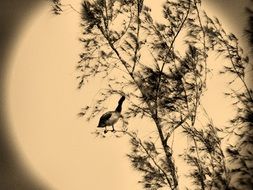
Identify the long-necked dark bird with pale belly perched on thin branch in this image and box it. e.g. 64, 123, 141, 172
97, 96, 125, 133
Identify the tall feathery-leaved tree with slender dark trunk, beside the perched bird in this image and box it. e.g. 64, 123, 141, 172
50, 0, 252, 190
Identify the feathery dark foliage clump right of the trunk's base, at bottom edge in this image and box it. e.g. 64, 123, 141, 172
183, 121, 230, 190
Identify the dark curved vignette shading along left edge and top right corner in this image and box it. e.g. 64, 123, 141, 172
0, 0, 253, 190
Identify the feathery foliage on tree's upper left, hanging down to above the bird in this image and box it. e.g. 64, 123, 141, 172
77, 0, 140, 120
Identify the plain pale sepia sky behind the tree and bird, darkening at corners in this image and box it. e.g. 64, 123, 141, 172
0, 0, 252, 190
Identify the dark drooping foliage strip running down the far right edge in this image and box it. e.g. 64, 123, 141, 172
203, 13, 253, 189
